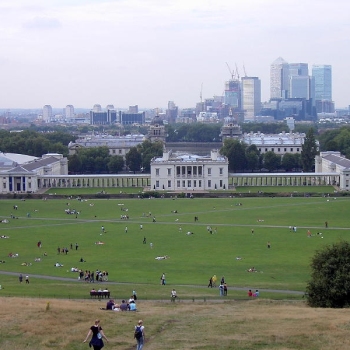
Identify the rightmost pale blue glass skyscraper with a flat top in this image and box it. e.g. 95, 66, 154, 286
312, 64, 332, 101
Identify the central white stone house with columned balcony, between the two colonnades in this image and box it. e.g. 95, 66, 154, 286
151, 150, 228, 192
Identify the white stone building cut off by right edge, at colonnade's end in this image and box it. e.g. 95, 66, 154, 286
315, 151, 350, 191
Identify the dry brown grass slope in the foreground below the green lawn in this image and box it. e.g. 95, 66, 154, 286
0, 298, 350, 350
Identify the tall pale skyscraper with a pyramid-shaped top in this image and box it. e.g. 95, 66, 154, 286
270, 57, 289, 99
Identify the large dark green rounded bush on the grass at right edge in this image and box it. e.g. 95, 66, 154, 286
306, 241, 350, 308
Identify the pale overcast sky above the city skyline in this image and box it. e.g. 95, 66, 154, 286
0, 0, 350, 109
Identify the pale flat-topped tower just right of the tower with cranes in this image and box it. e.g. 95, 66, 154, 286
242, 77, 261, 121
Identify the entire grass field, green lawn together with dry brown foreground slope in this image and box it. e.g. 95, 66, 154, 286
0, 196, 350, 350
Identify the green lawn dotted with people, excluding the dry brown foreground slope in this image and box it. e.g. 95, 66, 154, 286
0, 197, 350, 299
